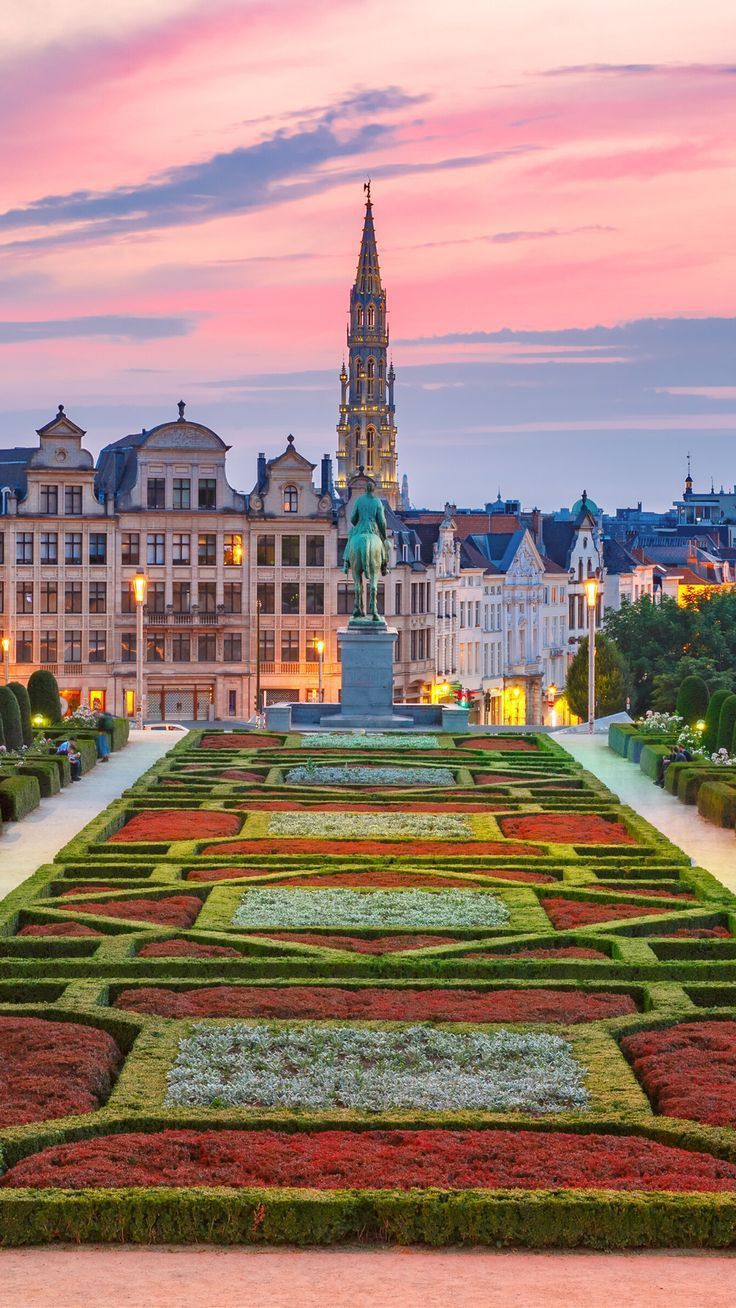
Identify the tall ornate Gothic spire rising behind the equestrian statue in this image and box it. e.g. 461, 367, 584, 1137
337, 182, 399, 509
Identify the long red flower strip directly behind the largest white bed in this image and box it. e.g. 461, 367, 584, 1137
114, 985, 638, 1023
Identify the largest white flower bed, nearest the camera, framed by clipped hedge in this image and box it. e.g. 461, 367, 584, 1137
166, 1023, 588, 1113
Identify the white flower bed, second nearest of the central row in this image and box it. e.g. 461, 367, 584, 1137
233, 887, 509, 927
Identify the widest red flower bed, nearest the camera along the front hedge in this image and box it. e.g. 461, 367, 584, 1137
0, 1130, 736, 1193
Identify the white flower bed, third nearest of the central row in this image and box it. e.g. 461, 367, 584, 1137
268, 812, 473, 840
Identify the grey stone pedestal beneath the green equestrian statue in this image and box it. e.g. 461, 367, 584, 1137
322, 617, 414, 730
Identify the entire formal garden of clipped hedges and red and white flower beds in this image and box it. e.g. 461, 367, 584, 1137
0, 730, 736, 1248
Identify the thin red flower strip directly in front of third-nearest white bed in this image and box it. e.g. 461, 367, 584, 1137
201, 837, 543, 858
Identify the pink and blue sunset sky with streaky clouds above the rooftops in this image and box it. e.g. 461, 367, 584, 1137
0, 0, 736, 510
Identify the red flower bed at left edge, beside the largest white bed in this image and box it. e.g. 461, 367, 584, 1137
0, 1018, 123, 1126
